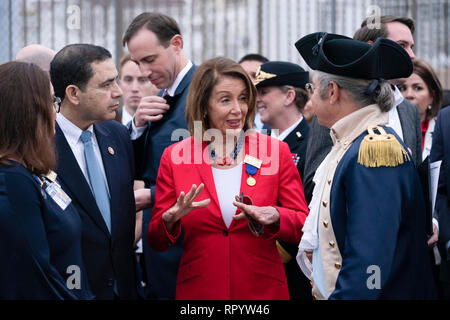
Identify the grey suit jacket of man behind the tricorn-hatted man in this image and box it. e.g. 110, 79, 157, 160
303, 99, 422, 203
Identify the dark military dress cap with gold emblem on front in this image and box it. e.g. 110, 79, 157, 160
255, 61, 309, 89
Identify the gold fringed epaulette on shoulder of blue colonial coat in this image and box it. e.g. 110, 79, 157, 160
358, 126, 411, 168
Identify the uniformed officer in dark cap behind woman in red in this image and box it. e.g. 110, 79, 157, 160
254, 61, 312, 300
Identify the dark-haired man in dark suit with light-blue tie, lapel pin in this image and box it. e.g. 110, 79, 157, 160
50, 44, 139, 299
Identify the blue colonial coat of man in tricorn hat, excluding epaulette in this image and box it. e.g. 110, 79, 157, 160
329, 127, 436, 300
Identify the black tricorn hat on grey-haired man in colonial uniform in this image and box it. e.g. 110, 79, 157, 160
295, 32, 413, 80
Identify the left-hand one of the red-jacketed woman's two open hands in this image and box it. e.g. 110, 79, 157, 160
162, 183, 211, 233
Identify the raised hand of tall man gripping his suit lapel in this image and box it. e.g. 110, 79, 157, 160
134, 96, 170, 128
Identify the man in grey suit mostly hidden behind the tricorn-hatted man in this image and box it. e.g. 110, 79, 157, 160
303, 16, 422, 203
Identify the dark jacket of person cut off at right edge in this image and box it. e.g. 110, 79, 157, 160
430, 108, 450, 285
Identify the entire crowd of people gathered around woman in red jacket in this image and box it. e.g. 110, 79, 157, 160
0, 12, 450, 300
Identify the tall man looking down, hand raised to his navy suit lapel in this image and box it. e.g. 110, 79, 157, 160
123, 13, 195, 299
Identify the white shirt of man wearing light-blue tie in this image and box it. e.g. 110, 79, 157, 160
56, 113, 109, 192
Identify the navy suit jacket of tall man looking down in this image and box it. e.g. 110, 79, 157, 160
133, 65, 196, 299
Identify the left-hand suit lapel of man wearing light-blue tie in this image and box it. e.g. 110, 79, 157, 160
55, 124, 110, 237
